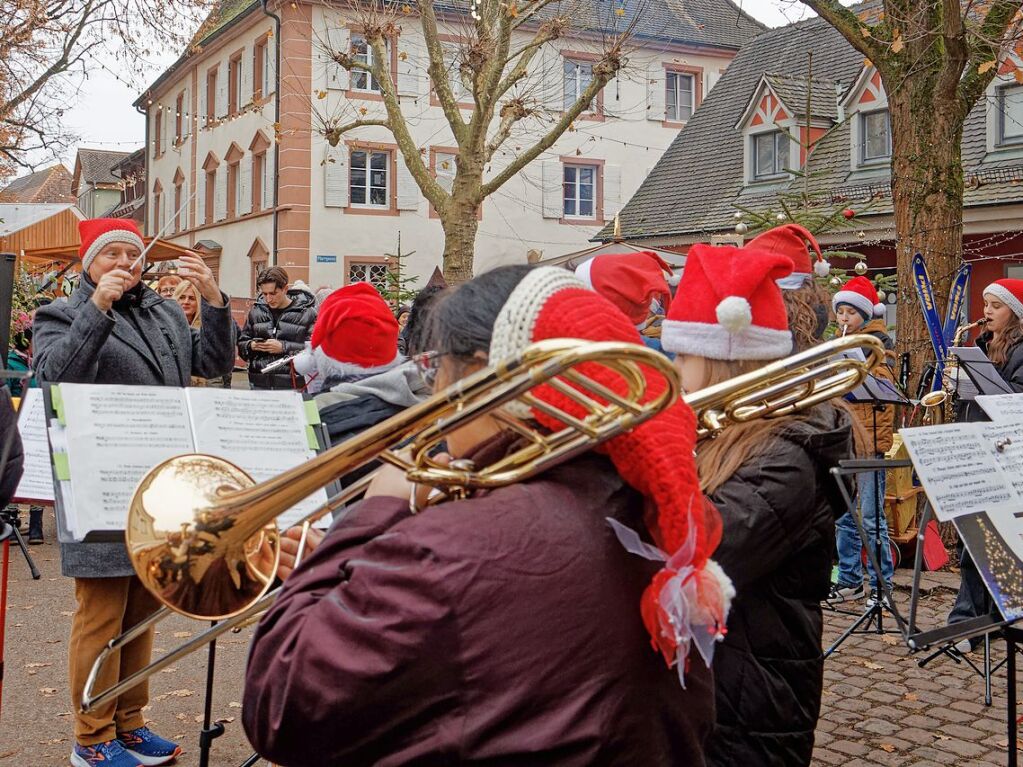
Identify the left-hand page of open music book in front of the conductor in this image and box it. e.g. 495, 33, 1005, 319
60, 384, 193, 537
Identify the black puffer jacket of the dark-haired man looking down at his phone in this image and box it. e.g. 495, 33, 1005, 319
238, 287, 316, 389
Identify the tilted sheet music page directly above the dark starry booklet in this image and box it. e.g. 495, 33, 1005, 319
899, 423, 1023, 522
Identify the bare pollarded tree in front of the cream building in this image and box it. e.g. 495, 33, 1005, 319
318, 0, 638, 281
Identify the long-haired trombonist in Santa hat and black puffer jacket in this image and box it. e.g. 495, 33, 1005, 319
661, 244, 853, 767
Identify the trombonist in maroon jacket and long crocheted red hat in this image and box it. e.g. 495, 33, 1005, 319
242, 266, 729, 766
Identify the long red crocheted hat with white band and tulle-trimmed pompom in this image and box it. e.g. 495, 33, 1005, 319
490, 267, 735, 684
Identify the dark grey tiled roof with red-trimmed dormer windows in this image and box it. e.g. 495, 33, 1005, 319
594, 6, 1023, 240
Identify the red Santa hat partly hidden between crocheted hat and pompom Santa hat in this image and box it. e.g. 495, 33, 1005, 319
576, 251, 671, 325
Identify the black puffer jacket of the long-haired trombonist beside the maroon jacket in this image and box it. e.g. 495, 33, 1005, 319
707, 405, 853, 767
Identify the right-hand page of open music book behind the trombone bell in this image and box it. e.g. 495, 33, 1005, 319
186, 388, 330, 530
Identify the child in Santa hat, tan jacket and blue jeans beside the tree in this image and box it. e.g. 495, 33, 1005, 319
828, 277, 895, 602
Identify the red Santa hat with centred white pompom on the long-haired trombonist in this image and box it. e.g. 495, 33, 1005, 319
661, 244, 792, 360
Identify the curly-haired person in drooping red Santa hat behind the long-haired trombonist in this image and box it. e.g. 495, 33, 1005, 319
747, 224, 831, 354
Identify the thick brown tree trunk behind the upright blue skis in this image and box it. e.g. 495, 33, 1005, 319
802, 0, 1021, 386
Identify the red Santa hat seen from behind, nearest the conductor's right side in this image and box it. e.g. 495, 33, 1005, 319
312, 282, 398, 369
